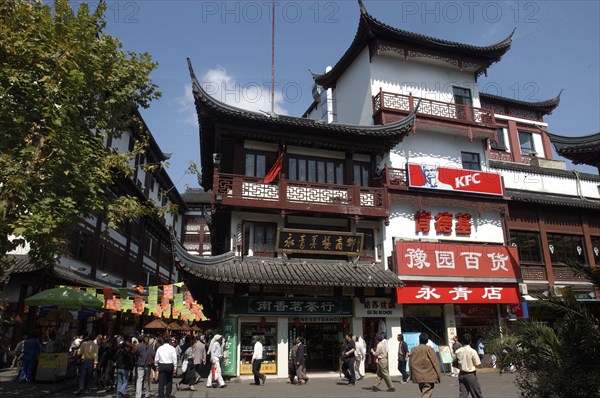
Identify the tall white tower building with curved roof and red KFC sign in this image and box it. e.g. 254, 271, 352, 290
305, 1, 520, 364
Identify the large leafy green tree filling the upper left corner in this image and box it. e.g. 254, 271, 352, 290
0, 0, 160, 272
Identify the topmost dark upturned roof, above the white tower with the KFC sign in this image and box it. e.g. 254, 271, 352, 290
311, 0, 515, 87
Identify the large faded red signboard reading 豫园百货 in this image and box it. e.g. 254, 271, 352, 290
396, 241, 520, 279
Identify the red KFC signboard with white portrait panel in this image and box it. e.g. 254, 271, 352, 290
407, 163, 504, 195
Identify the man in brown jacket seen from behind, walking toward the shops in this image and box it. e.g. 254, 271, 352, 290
409, 333, 441, 398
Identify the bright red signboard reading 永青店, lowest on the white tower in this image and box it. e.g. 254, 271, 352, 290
396, 282, 520, 304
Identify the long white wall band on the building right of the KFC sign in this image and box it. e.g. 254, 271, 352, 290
493, 169, 600, 199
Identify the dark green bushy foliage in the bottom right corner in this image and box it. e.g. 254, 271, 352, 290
488, 263, 600, 398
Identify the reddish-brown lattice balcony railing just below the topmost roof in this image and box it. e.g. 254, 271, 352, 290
373, 91, 496, 128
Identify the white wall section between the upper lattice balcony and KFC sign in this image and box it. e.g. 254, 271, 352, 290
386, 129, 488, 170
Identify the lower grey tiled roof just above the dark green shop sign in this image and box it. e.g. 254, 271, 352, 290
173, 235, 404, 288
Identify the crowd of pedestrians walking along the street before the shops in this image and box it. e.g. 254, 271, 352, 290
5, 332, 492, 398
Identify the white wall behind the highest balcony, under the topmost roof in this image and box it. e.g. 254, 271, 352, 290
371, 55, 481, 108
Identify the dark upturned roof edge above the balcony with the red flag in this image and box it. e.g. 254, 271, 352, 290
187, 58, 419, 137
